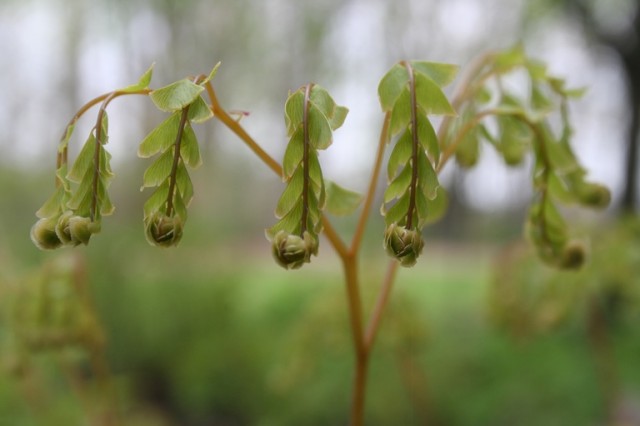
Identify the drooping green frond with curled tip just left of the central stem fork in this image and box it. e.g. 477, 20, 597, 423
266, 84, 352, 269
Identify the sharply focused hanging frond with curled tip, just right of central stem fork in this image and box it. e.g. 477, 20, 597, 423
378, 62, 457, 266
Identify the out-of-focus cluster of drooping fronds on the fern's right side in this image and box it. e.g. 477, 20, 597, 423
441, 46, 610, 268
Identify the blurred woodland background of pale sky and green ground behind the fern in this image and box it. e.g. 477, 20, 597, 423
0, 0, 640, 425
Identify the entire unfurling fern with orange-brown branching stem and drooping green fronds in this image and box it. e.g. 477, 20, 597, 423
31, 47, 610, 425
